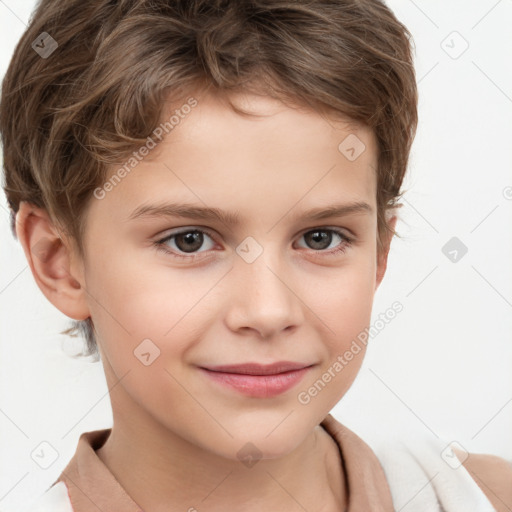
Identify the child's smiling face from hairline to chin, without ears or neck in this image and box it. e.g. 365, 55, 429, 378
68, 90, 385, 459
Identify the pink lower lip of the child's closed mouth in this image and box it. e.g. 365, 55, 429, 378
201, 367, 310, 398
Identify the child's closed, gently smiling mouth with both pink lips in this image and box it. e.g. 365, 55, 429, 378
199, 361, 315, 398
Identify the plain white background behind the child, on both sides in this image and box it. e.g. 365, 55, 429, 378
0, 0, 512, 511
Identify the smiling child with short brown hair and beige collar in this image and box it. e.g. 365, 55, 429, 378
0, 0, 512, 512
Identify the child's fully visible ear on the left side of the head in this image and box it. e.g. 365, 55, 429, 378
16, 201, 90, 320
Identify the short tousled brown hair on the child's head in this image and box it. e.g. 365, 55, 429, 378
0, 0, 417, 355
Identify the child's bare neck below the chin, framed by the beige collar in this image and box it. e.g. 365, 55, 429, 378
96, 410, 347, 512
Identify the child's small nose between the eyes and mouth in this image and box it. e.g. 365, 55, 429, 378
226, 249, 303, 339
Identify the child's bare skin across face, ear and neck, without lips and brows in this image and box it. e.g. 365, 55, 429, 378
17, 89, 396, 512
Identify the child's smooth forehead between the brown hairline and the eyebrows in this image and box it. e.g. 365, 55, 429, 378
88, 89, 377, 230
